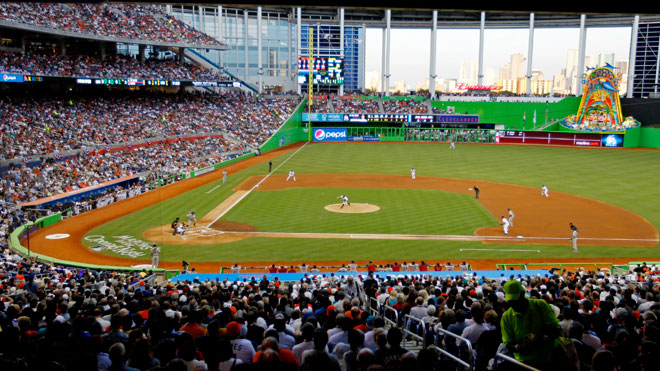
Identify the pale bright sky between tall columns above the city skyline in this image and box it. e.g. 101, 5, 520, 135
365, 27, 631, 89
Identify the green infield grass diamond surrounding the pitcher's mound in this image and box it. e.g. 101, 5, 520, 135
223, 188, 497, 234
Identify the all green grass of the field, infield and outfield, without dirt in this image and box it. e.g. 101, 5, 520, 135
88, 143, 660, 262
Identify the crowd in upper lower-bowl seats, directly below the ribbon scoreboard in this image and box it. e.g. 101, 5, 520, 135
0, 92, 297, 159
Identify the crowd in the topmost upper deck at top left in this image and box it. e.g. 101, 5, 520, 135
0, 2, 222, 46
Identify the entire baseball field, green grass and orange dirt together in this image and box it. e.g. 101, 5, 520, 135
31, 143, 660, 272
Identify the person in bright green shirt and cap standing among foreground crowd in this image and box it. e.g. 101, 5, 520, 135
501, 280, 561, 369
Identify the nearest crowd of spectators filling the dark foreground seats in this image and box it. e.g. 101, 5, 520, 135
0, 250, 660, 371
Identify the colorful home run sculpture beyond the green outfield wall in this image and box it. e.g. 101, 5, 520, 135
562, 65, 639, 131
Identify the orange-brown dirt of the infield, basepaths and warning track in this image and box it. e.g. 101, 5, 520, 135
23, 145, 658, 272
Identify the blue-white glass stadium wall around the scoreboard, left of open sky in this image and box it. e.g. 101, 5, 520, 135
165, 5, 366, 92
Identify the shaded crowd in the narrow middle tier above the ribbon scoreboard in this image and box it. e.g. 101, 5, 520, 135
0, 52, 226, 81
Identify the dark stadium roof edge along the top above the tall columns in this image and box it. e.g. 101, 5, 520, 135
172, 0, 660, 28
